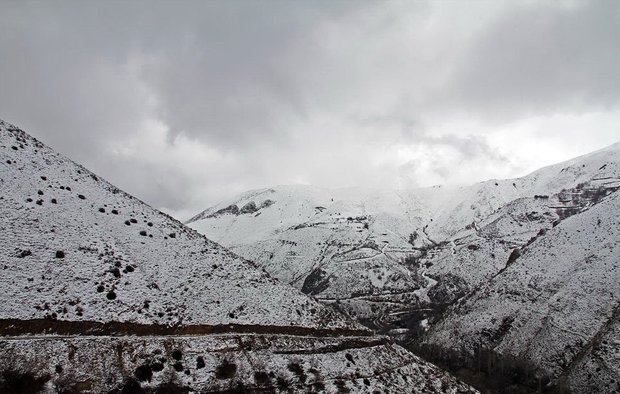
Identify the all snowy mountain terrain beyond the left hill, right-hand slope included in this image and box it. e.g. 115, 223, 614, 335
189, 143, 620, 392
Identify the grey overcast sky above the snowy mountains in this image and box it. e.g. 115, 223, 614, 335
0, 0, 620, 219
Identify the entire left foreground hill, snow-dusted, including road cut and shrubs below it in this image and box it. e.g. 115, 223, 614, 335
0, 121, 473, 393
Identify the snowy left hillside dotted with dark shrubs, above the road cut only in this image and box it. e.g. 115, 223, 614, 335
0, 122, 357, 328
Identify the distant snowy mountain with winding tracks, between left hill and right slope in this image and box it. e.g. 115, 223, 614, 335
188, 144, 620, 336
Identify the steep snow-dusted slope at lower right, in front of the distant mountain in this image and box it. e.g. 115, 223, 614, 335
425, 192, 620, 392
